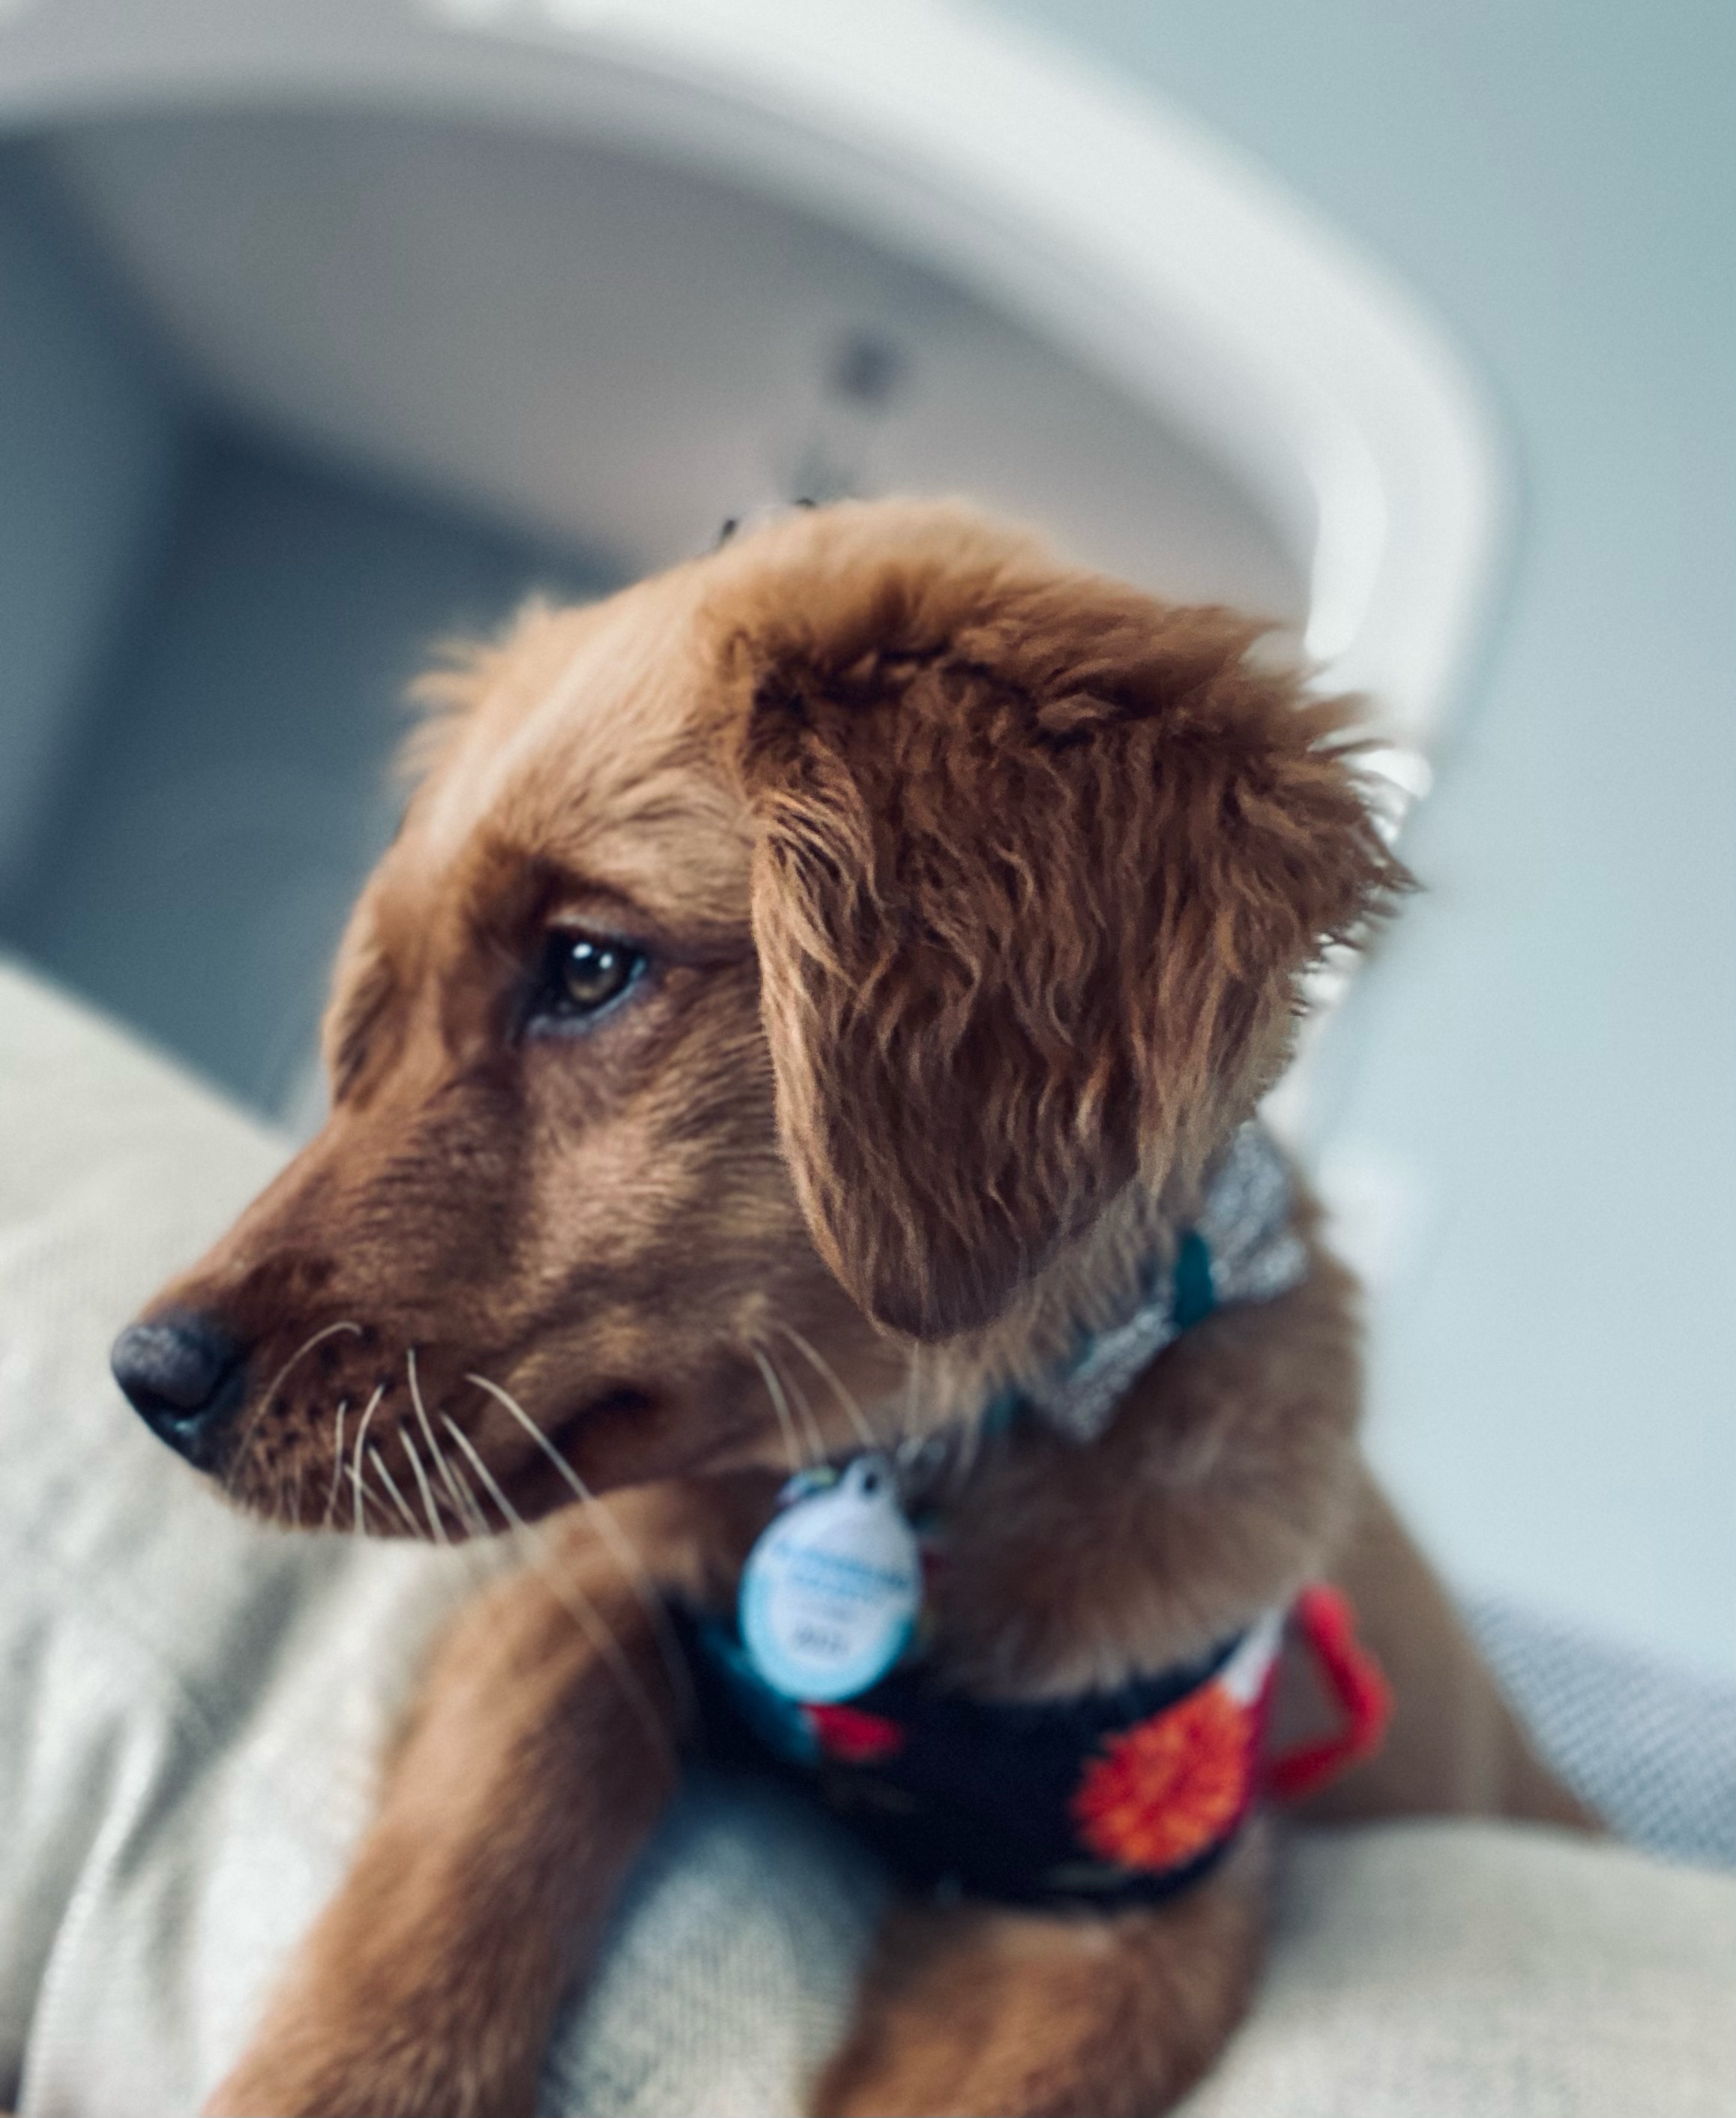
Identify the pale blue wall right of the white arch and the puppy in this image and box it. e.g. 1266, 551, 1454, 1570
1001, 0, 1736, 1669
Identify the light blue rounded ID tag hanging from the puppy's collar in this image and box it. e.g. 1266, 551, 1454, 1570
737, 1455, 923, 1705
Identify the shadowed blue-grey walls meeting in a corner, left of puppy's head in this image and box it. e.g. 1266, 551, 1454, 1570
0, 142, 612, 1119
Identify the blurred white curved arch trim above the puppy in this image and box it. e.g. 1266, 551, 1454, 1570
0, 0, 1507, 762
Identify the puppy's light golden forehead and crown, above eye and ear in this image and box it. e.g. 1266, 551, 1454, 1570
390, 502, 1040, 932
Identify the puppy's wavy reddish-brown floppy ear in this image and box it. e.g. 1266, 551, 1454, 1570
729, 517, 1405, 1338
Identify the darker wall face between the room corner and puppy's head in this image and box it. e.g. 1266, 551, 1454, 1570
6, 434, 599, 1116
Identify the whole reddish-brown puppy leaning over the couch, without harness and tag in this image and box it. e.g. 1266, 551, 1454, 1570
118, 504, 1573, 2118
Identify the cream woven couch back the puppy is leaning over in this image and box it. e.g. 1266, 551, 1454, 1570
0, 966, 1736, 2118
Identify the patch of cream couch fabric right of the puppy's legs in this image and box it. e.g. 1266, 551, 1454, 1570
1186, 1823, 1736, 2118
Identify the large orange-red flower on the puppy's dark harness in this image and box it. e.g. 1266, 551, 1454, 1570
1071, 1684, 1253, 1870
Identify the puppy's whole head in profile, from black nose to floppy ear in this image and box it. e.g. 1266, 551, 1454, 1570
116, 502, 1404, 1531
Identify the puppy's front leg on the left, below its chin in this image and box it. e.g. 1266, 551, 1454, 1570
208, 1529, 675, 2118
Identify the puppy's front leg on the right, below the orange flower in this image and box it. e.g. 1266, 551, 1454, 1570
813, 1823, 1268, 2118
